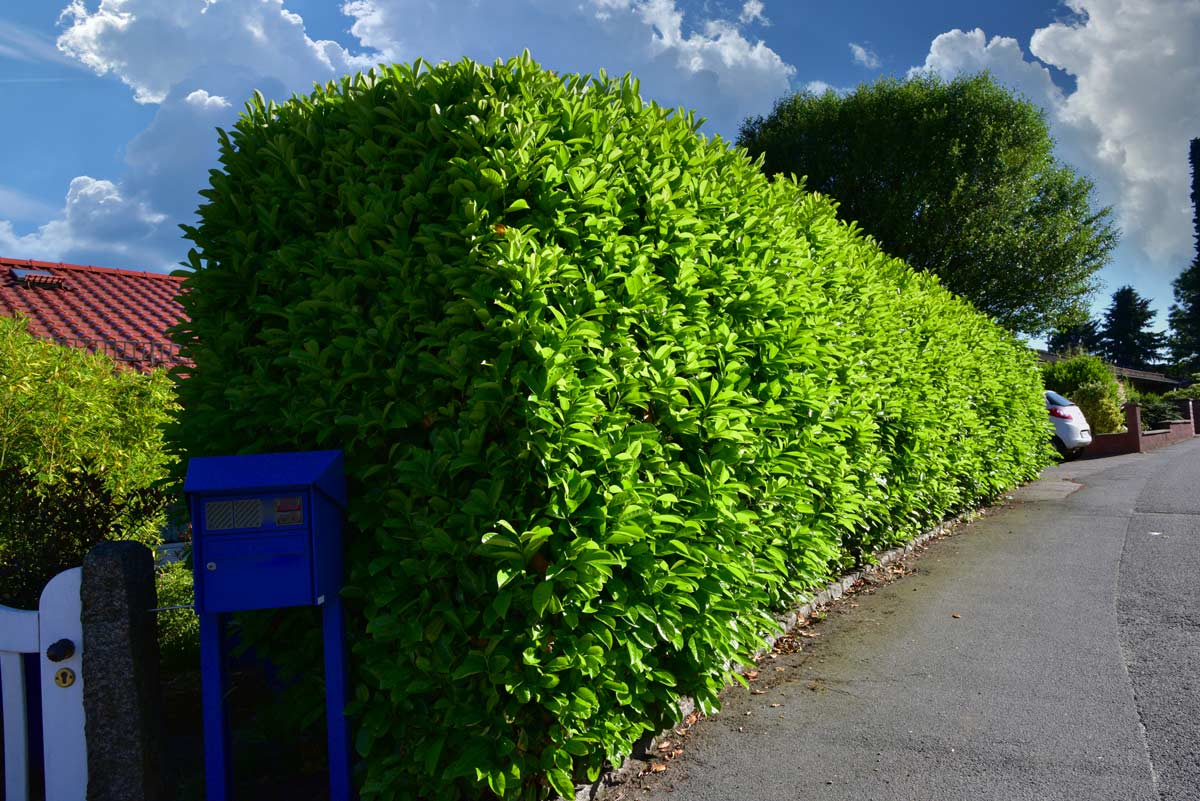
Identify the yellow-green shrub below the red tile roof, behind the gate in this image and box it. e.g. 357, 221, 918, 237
0, 317, 174, 608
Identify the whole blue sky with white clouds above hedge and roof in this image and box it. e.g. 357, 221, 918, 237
0, 0, 1200, 335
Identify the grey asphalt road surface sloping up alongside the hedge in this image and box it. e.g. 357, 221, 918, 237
618, 438, 1200, 801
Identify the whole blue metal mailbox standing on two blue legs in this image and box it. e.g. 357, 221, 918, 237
184, 451, 350, 801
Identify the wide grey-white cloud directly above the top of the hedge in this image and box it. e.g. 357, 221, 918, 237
342, 0, 796, 137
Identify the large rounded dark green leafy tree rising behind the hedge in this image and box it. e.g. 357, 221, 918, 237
738, 73, 1117, 335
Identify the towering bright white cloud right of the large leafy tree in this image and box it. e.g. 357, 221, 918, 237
920, 0, 1200, 316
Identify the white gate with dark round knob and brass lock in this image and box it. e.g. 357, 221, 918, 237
0, 567, 88, 801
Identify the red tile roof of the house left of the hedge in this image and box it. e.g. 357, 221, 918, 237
0, 257, 184, 369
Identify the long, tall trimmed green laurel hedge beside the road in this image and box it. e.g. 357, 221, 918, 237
174, 56, 1049, 800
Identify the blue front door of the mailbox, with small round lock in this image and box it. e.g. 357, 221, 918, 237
194, 529, 316, 612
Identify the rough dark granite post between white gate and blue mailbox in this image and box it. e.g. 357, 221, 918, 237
79, 541, 163, 801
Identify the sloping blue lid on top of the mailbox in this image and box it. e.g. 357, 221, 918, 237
184, 451, 346, 508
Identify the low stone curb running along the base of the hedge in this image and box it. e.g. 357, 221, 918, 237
554, 506, 984, 801
